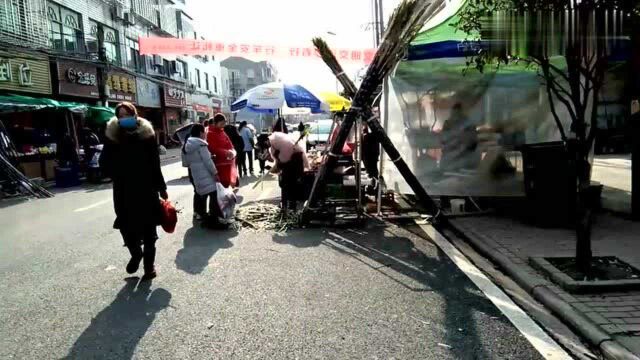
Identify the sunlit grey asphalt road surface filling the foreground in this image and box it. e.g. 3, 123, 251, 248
0, 164, 556, 359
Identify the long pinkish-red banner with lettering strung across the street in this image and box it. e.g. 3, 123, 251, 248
139, 37, 376, 65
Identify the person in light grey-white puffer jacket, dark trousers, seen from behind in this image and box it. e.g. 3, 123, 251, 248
182, 124, 221, 224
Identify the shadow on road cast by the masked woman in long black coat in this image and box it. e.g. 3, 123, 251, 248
66, 278, 171, 359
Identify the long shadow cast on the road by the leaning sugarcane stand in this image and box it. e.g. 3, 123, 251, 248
273, 224, 537, 359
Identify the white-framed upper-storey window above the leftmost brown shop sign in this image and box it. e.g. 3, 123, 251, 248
47, 2, 84, 52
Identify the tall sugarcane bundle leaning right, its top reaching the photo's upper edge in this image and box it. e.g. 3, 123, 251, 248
307, 0, 444, 205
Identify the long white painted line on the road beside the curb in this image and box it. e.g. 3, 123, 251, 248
418, 224, 571, 360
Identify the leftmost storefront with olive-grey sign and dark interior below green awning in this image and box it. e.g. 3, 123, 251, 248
0, 51, 61, 179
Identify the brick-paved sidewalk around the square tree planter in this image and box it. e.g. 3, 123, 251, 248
451, 213, 640, 355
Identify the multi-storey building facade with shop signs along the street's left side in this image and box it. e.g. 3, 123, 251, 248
0, 0, 224, 143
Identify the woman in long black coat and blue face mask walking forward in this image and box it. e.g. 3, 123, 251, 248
100, 102, 169, 280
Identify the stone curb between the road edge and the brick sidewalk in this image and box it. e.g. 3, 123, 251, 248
445, 221, 640, 360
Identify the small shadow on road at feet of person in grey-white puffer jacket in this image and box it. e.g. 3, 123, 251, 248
176, 225, 237, 275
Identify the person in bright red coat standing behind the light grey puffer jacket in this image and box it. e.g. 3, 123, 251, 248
207, 114, 238, 187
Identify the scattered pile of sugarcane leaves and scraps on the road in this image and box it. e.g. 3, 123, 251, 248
236, 202, 300, 234
